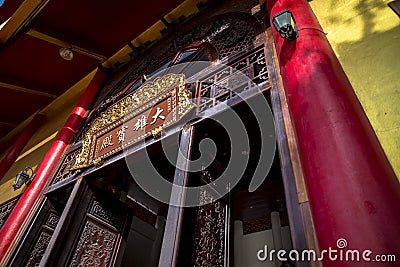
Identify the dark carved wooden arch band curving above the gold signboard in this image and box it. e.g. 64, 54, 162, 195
77, 13, 260, 152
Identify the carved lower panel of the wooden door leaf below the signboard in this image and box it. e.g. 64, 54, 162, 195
70, 220, 118, 266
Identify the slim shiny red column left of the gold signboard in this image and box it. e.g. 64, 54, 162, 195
0, 70, 105, 262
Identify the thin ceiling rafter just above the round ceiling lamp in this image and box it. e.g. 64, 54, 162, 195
26, 29, 107, 63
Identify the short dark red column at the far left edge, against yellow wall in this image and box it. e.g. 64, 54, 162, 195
0, 113, 46, 180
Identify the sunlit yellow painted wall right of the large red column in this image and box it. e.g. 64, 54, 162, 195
310, 0, 400, 178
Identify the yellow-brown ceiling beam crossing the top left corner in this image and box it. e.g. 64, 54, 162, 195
0, 0, 50, 44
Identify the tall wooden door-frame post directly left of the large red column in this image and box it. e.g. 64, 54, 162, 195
265, 28, 321, 267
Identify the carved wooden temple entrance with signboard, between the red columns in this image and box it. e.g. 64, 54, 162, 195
1, 1, 318, 267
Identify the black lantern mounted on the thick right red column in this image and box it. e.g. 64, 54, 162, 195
272, 9, 299, 40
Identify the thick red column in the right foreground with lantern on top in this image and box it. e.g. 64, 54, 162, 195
267, 0, 400, 266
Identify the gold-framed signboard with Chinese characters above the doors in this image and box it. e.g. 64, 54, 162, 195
73, 74, 194, 169
